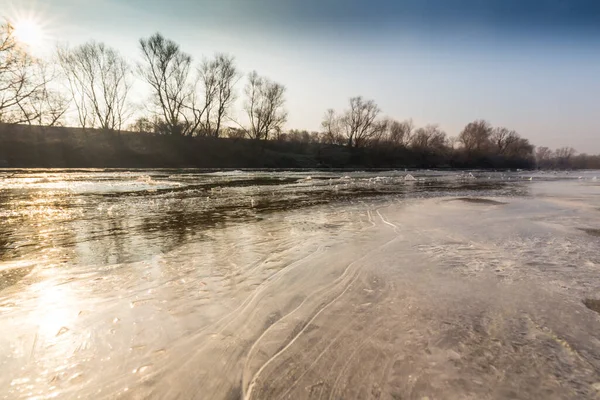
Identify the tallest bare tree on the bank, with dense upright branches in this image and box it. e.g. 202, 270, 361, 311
138, 33, 210, 136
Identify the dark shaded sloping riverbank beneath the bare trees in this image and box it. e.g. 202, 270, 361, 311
0, 124, 533, 169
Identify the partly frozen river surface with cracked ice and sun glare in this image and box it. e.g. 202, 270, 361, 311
0, 170, 600, 399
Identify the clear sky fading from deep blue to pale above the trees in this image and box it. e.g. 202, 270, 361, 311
0, 0, 600, 153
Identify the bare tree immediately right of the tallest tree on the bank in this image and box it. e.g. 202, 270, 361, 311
200, 54, 238, 137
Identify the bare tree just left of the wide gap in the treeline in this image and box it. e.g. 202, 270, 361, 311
245, 71, 287, 140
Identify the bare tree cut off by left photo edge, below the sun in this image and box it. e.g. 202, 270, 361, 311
0, 23, 66, 125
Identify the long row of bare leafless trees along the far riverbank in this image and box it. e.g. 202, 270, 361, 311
0, 23, 600, 168
